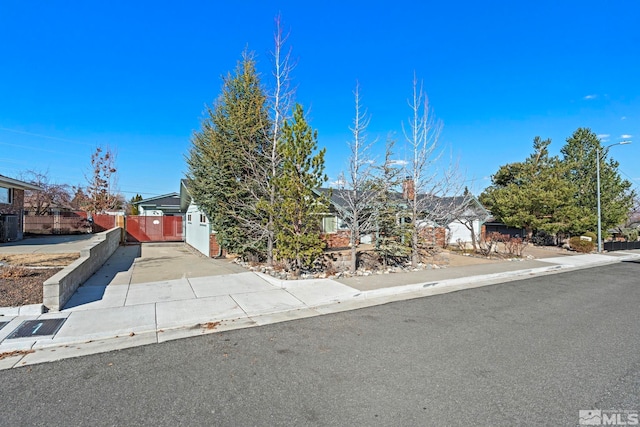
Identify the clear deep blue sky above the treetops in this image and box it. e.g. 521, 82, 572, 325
0, 0, 640, 199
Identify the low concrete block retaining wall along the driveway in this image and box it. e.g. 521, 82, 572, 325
43, 227, 122, 311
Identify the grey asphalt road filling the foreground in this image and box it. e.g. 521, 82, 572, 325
0, 262, 640, 426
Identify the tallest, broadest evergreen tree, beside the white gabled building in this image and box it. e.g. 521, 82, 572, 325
187, 53, 270, 255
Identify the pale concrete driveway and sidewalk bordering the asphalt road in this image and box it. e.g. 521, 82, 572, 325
0, 246, 640, 369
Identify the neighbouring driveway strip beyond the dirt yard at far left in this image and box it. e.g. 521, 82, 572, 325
0, 234, 95, 254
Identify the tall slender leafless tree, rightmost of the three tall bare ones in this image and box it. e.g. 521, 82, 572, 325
403, 74, 463, 267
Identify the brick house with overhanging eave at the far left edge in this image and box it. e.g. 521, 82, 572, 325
0, 175, 42, 242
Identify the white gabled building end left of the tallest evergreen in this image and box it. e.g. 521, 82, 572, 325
180, 179, 224, 258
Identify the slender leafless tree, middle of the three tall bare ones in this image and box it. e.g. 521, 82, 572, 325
337, 83, 376, 272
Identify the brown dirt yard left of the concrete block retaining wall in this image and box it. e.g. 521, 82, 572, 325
0, 253, 80, 307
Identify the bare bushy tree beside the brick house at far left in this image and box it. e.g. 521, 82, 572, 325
21, 170, 71, 215
